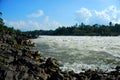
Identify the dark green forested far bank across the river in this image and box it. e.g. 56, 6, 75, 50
25, 22, 120, 36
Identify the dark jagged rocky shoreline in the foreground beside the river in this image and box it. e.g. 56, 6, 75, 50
0, 31, 120, 80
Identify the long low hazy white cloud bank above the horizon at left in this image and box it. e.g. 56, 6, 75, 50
4, 16, 61, 31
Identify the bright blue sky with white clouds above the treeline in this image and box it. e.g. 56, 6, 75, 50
0, 0, 120, 31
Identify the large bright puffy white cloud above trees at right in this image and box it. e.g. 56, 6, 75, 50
75, 5, 120, 24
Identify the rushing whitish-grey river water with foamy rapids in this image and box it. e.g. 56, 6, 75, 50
32, 36, 120, 73
